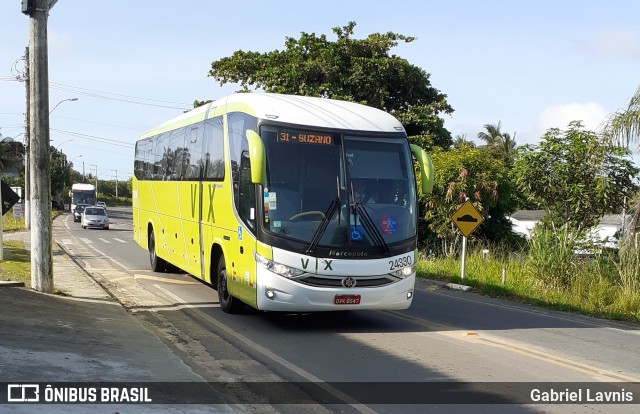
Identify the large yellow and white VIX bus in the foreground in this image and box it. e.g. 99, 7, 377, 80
133, 93, 433, 313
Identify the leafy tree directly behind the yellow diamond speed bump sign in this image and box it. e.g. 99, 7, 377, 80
421, 146, 515, 255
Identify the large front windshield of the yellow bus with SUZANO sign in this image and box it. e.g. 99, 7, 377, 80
261, 126, 416, 249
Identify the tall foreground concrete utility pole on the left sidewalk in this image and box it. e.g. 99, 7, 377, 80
23, 0, 54, 293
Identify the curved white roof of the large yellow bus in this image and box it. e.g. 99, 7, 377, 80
140, 93, 404, 138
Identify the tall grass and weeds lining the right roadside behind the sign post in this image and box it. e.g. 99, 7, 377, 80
418, 238, 640, 322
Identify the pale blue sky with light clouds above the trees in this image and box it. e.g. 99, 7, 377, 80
0, 0, 640, 180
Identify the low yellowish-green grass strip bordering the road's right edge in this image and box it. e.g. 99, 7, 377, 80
418, 246, 640, 322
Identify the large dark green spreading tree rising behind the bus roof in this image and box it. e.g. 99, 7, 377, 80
208, 22, 453, 149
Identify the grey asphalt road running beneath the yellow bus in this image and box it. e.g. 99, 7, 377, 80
54, 208, 640, 413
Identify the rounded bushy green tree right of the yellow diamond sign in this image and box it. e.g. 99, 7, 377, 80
514, 121, 639, 238
